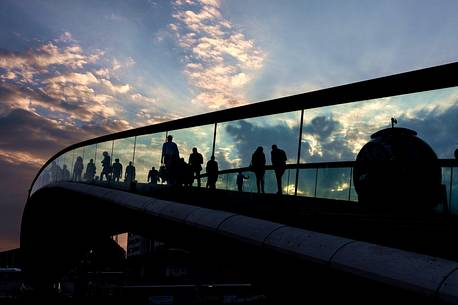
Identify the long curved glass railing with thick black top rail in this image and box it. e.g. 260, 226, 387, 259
29, 63, 458, 214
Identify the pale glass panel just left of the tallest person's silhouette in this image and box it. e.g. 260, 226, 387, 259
135, 132, 165, 183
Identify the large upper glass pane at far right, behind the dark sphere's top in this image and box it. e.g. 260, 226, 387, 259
301, 87, 458, 162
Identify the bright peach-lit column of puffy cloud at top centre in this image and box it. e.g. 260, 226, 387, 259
169, 0, 266, 108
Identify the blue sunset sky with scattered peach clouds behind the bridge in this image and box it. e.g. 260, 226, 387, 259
0, 0, 458, 251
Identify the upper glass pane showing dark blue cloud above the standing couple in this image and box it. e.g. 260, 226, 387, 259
215, 111, 300, 171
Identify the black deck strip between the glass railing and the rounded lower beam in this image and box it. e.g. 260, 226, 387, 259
89, 180, 458, 261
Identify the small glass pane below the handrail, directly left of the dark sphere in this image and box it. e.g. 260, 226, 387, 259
316, 168, 350, 200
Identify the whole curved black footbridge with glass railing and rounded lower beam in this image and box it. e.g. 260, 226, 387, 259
21, 63, 458, 303
